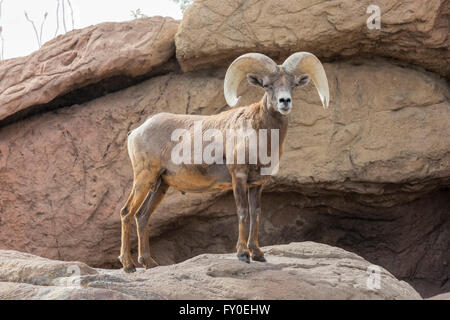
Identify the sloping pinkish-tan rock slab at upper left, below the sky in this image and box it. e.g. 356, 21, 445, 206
0, 17, 178, 121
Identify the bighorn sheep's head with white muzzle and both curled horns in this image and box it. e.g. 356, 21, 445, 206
224, 52, 330, 115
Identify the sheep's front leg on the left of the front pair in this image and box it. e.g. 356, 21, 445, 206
231, 171, 250, 263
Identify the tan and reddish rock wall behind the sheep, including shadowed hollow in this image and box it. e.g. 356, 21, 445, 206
0, 0, 450, 298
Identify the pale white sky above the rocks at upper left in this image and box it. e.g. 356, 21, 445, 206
0, 0, 182, 59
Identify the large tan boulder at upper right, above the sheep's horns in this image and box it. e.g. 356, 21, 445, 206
176, 0, 450, 76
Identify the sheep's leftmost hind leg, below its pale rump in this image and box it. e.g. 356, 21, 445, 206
119, 171, 151, 273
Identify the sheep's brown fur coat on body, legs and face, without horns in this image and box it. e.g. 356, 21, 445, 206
119, 70, 310, 272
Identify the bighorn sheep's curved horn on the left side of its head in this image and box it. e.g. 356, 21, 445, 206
224, 53, 278, 107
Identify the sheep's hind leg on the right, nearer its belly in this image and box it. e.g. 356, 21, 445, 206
135, 171, 169, 269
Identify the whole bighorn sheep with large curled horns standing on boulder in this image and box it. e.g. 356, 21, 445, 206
119, 52, 329, 272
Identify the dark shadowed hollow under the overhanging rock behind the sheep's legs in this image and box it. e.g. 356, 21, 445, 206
115, 187, 450, 297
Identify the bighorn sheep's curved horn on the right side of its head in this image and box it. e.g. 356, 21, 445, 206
283, 52, 330, 109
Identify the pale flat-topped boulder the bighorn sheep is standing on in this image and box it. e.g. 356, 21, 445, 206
0, 242, 421, 300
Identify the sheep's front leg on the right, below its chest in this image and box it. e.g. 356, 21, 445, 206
247, 185, 266, 262
